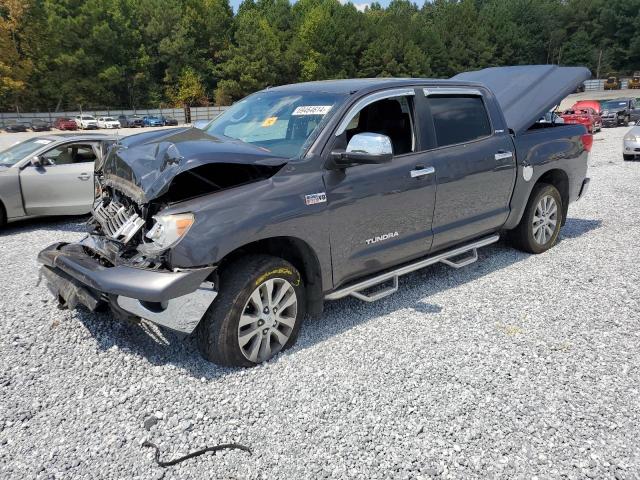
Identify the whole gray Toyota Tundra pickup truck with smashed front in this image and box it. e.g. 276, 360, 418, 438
39, 66, 592, 366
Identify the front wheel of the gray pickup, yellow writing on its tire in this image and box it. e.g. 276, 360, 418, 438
196, 255, 306, 367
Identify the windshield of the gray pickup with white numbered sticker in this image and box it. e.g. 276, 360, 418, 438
206, 91, 344, 158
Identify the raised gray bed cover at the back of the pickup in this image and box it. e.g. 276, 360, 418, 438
452, 65, 591, 134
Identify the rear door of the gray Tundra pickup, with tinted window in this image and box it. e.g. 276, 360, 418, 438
424, 88, 516, 250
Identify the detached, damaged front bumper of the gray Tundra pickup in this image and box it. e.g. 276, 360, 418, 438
38, 243, 217, 333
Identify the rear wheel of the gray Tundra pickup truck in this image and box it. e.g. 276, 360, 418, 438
510, 183, 564, 254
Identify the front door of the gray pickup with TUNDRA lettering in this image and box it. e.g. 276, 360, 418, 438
324, 89, 435, 286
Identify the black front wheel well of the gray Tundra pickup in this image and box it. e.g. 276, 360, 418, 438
219, 237, 324, 315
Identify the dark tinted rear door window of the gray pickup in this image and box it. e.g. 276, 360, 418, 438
429, 96, 491, 147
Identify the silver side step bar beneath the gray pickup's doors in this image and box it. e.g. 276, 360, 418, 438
324, 234, 500, 302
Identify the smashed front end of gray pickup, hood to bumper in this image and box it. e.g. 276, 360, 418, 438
38, 129, 284, 334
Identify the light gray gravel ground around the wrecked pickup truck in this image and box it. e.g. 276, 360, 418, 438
0, 128, 640, 480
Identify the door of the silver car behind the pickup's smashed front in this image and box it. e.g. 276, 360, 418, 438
20, 142, 99, 215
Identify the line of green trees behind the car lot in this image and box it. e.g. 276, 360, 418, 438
0, 0, 640, 110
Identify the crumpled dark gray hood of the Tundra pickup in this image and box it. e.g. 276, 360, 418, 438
99, 128, 287, 204
